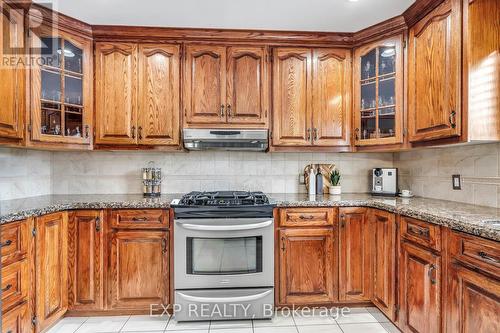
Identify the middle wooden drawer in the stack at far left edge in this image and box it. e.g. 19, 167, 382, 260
2, 259, 29, 311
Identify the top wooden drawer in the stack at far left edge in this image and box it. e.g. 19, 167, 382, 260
0, 221, 29, 265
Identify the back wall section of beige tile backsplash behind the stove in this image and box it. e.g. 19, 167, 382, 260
52, 151, 393, 194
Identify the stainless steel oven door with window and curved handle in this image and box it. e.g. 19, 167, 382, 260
174, 218, 274, 290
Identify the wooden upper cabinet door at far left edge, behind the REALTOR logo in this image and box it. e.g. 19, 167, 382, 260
0, 3, 25, 139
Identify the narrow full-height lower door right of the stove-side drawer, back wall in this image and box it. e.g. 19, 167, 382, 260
339, 208, 372, 302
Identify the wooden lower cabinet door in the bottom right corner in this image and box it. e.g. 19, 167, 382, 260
446, 263, 500, 333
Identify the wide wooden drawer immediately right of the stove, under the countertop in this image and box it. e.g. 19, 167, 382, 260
280, 208, 337, 227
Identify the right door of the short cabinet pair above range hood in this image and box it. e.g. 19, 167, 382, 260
226, 47, 269, 126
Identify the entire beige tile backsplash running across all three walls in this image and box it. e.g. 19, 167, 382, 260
0, 143, 500, 208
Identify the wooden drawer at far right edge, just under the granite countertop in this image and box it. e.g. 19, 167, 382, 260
449, 231, 500, 278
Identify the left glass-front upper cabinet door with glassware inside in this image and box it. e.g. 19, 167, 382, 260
31, 26, 92, 144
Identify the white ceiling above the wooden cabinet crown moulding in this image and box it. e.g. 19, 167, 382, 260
35, 0, 414, 32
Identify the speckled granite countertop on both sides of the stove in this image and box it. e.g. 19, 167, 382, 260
0, 193, 500, 241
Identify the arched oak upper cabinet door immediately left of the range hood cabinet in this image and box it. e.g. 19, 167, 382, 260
137, 44, 180, 145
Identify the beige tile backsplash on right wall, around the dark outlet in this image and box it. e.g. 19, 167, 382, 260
394, 143, 500, 208
